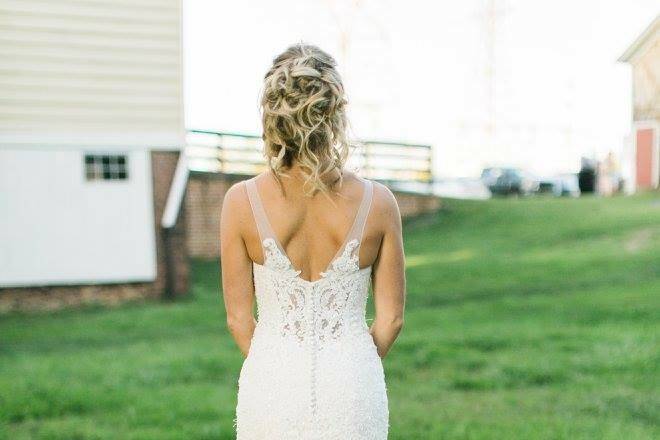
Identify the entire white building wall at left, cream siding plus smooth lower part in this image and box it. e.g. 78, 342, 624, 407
0, 0, 184, 287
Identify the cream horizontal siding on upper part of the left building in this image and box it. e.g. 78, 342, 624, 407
0, 0, 184, 148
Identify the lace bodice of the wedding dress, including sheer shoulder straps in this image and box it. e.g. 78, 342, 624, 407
248, 181, 372, 350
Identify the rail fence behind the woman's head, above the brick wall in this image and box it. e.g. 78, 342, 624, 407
186, 130, 433, 186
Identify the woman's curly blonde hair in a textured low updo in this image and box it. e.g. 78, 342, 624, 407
261, 43, 350, 194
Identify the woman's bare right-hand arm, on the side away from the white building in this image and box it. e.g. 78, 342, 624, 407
370, 185, 406, 358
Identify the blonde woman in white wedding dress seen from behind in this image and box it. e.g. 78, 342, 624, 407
221, 44, 405, 440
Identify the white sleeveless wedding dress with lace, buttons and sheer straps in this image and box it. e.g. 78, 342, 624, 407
236, 179, 389, 440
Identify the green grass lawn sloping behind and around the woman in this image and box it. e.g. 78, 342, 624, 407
0, 195, 660, 440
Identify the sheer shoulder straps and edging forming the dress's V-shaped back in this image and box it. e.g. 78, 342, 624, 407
245, 177, 373, 282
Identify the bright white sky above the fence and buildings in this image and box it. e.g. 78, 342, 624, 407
184, 0, 660, 178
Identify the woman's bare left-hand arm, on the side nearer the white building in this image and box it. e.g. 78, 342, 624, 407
220, 183, 256, 357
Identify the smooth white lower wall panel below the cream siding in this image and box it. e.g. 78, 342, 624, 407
0, 150, 156, 287
